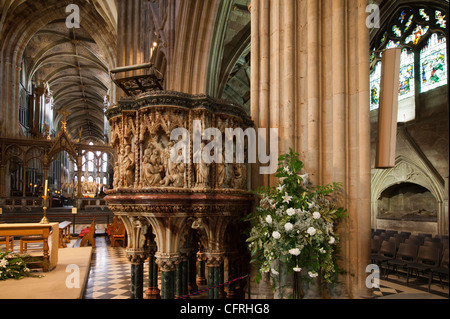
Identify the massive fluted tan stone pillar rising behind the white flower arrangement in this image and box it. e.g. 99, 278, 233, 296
251, 0, 370, 298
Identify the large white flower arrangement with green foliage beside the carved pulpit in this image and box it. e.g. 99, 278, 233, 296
246, 149, 347, 297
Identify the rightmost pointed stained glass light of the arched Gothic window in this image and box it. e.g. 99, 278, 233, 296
420, 33, 447, 92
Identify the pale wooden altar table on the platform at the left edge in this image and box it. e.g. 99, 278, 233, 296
0, 223, 59, 271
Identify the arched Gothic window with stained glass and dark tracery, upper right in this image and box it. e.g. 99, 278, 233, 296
370, 4, 448, 112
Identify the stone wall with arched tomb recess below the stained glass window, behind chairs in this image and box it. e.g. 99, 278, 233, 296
371, 85, 449, 235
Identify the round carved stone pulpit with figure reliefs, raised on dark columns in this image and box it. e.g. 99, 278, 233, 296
105, 91, 254, 299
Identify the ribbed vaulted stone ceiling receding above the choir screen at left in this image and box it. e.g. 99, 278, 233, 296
24, 20, 111, 140
